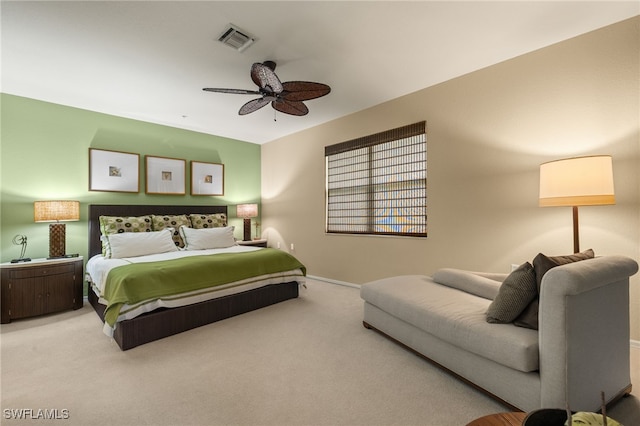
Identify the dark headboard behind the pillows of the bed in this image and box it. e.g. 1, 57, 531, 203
89, 204, 228, 258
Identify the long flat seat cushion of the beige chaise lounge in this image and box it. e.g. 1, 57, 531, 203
360, 275, 539, 372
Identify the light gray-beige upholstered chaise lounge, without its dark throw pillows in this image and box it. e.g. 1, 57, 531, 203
361, 256, 638, 411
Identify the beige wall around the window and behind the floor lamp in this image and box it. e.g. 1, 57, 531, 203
262, 17, 640, 340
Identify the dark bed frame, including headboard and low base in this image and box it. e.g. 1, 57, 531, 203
87, 204, 298, 351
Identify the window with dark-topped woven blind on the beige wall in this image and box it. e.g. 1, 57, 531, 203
325, 121, 427, 237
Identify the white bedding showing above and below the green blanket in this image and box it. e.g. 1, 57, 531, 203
86, 245, 305, 337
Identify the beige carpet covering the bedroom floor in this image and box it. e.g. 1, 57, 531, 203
0, 280, 640, 426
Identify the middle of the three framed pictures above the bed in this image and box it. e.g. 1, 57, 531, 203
144, 155, 187, 195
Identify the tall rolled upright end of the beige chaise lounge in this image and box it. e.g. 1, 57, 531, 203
539, 256, 638, 411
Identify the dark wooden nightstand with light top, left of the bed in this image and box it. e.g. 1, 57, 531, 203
0, 256, 84, 324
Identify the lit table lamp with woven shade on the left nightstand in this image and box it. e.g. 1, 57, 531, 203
33, 200, 80, 259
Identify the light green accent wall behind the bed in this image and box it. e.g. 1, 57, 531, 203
0, 94, 261, 262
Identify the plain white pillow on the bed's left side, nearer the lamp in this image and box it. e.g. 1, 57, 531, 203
101, 228, 178, 259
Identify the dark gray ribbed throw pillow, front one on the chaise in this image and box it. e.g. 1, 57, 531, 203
487, 262, 538, 324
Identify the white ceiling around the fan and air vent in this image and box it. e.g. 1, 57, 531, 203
0, 0, 640, 144
